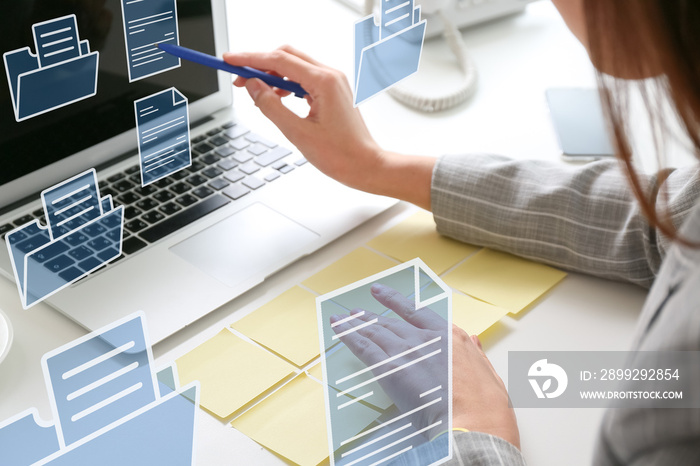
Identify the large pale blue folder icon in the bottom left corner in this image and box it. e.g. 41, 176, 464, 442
0, 313, 199, 466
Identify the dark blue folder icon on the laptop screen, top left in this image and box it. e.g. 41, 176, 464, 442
3, 15, 99, 121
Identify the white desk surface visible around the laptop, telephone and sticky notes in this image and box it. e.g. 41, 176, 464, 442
0, 0, 646, 465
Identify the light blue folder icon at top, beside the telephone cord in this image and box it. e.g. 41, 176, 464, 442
354, 0, 426, 106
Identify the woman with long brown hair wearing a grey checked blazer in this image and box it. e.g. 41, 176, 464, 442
224, 0, 700, 465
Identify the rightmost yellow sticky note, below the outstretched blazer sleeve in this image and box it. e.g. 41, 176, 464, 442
444, 249, 566, 314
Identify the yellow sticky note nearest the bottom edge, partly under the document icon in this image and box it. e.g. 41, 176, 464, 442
231, 374, 379, 466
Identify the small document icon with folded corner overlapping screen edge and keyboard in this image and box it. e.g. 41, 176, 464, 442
134, 87, 192, 186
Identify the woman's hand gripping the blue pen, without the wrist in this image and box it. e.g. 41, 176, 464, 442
224, 46, 382, 191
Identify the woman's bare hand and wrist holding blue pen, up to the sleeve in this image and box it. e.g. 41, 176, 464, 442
224, 46, 435, 210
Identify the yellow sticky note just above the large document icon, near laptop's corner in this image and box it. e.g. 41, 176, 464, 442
302, 248, 397, 294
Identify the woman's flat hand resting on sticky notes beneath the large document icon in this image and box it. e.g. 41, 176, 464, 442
331, 285, 520, 448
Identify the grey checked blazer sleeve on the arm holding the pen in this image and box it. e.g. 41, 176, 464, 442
431, 155, 700, 288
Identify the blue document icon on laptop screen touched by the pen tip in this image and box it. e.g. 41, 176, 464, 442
121, 0, 180, 82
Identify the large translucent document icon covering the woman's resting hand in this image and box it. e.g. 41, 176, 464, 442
316, 259, 452, 466
